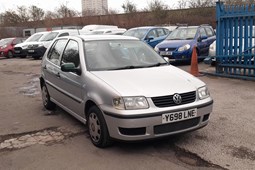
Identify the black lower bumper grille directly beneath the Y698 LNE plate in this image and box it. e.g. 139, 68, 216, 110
154, 117, 200, 134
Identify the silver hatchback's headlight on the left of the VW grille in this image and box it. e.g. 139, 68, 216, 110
113, 96, 149, 110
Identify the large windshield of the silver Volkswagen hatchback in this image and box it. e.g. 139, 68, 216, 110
85, 40, 168, 71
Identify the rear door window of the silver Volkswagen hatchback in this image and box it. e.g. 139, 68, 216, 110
47, 39, 67, 65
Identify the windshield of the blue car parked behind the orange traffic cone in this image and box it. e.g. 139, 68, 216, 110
167, 28, 197, 40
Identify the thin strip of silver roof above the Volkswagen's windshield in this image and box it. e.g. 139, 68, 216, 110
70, 34, 139, 41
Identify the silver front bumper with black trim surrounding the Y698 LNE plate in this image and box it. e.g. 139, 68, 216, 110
103, 99, 213, 141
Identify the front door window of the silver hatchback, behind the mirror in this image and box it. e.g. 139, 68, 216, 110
61, 40, 80, 67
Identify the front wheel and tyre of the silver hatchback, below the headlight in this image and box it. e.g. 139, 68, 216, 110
87, 106, 111, 148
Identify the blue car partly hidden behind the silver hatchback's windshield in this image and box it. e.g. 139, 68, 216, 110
123, 26, 170, 48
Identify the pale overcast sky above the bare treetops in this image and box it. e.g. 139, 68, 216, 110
0, 0, 179, 13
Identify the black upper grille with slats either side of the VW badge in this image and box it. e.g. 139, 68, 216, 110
151, 91, 196, 107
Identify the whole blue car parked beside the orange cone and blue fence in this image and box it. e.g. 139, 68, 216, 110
154, 25, 216, 62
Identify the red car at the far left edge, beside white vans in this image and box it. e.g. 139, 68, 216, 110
0, 37, 23, 58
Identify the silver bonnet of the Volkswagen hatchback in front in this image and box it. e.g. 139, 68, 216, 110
92, 66, 204, 97
